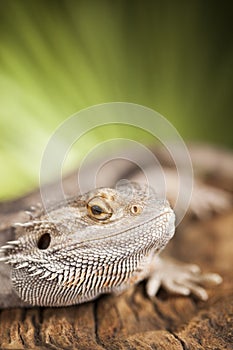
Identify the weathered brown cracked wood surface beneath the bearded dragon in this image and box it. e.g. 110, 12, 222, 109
0, 152, 233, 350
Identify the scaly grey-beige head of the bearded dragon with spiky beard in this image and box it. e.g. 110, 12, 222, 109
0, 183, 174, 306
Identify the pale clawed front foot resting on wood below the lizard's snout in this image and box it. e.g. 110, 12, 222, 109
146, 257, 222, 300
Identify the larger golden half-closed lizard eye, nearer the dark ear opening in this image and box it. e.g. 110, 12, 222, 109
87, 197, 112, 221
